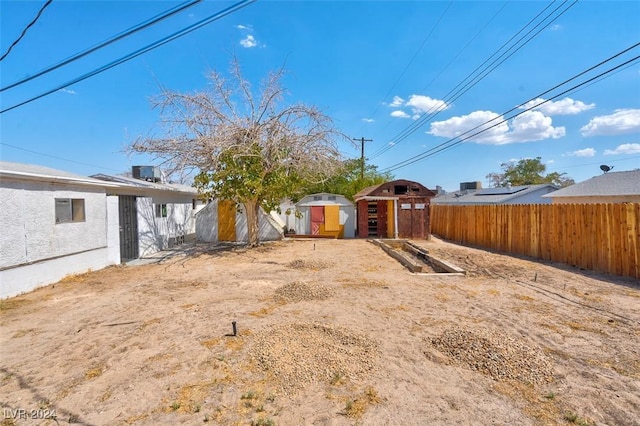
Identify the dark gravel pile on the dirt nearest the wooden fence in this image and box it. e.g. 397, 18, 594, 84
431, 327, 553, 384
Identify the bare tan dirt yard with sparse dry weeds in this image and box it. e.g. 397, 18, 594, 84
0, 239, 640, 425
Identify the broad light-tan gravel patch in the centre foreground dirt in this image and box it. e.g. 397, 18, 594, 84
250, 323, 379, 394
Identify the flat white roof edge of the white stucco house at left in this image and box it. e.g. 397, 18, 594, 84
0, 161, 117, 188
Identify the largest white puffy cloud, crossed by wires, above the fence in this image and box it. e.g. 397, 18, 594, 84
427, 111, 565, 145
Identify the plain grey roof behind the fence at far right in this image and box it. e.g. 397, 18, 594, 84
545, 170, 640, 197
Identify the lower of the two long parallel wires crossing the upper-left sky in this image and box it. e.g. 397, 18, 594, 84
0, 0, 256, 114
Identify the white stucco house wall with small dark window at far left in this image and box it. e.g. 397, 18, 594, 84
0, 179, 114, 298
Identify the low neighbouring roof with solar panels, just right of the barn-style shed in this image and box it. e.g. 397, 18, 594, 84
431, 184, 557, 204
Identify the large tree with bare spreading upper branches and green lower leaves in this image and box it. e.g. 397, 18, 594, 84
129, 58, 349, 245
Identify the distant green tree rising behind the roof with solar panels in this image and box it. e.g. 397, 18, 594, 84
486, 157, 575, 187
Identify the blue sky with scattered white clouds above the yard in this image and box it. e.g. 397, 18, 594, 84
0, 0, 640, 191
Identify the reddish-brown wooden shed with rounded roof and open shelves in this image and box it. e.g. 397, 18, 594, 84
354, 179, 436, 239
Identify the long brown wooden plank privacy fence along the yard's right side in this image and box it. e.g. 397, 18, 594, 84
431, 203, 640, 278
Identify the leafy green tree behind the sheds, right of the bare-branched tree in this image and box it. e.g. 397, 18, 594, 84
294, 158, 393, 201
